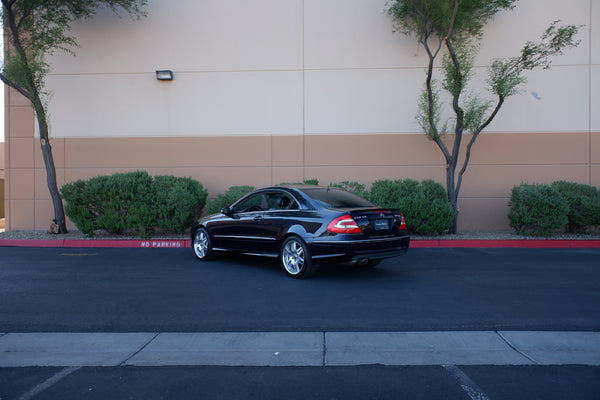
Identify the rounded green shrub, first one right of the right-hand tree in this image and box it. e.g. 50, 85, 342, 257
508, 183, 569, 236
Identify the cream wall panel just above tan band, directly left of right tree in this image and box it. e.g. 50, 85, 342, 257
305, 69, 425, 134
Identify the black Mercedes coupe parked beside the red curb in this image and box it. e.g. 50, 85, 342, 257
190, 186, 410, 278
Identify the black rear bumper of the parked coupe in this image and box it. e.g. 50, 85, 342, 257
307, 236, 410, 262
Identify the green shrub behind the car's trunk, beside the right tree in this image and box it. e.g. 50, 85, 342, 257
368, 179, 454, 235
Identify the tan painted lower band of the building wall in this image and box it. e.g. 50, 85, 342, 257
7, 132, 600, 229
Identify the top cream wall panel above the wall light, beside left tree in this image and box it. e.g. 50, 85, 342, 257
50, 0, 302, 74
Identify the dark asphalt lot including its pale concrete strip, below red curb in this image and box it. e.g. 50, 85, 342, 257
0, 247, 600, 399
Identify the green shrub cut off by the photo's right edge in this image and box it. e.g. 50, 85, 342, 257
552, 181, 600, 233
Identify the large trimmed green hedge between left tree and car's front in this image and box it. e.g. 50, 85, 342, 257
61, 171, 207, 238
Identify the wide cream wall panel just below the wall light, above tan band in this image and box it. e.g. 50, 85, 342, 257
48, 71, 302, 137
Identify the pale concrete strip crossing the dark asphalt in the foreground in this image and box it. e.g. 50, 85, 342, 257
0, 331, 600, 367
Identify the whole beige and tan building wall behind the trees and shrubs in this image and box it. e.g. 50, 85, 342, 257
5, 0, 600, 229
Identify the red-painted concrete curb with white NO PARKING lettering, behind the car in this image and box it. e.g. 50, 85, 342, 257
0, 238, 600, 249
